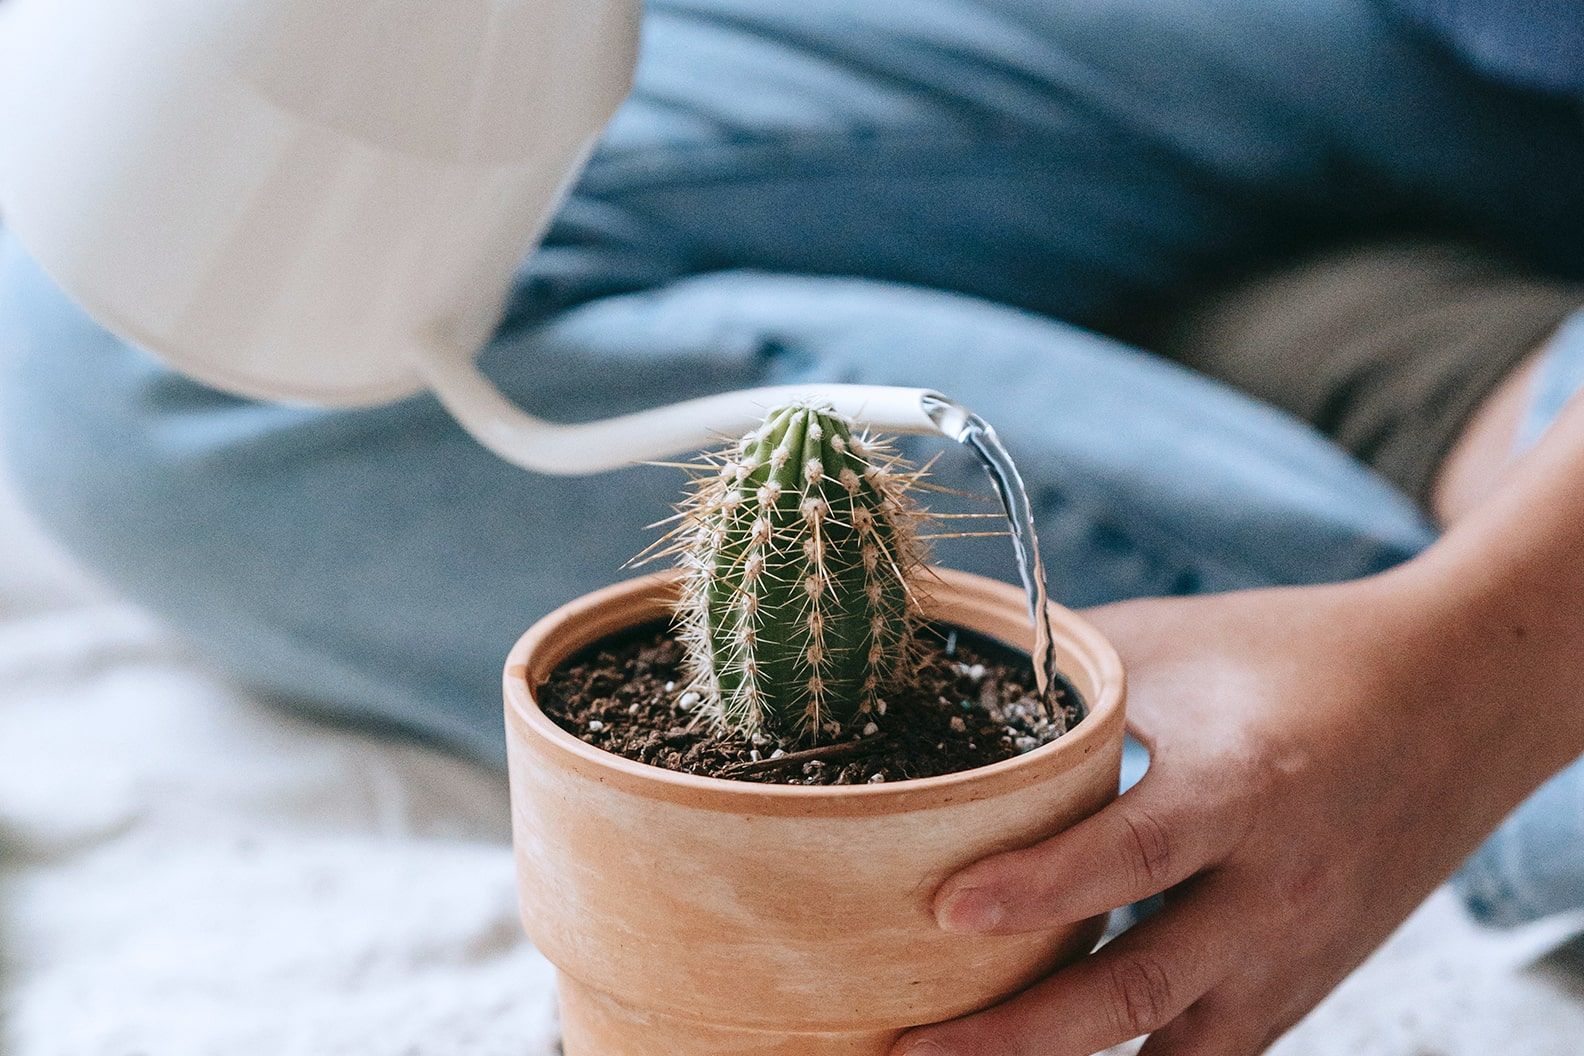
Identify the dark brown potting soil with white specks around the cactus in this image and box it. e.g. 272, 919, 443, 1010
537, 624, 1082, 785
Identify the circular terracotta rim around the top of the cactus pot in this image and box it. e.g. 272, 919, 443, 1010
504, 568, 1126, 814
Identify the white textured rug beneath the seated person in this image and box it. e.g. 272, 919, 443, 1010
0, 471, 1584, 1056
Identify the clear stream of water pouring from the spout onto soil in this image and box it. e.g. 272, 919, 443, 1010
923, 396, 1064, 716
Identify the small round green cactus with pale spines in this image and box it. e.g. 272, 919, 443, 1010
670, 402, 923, 743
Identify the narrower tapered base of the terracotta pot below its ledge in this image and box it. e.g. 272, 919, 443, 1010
559, 974, 901, 1056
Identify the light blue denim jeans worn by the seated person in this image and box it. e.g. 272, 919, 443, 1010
0, 0, 1584, 918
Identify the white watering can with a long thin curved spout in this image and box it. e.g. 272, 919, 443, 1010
0, 0, 960, 473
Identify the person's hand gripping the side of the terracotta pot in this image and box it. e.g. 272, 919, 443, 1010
893, 573, 1567, 1056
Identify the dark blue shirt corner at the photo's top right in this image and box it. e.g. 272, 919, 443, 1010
1392, 0, 1584, 100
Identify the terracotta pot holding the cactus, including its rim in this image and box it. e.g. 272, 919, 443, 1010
505, 572, 1123, 1056
